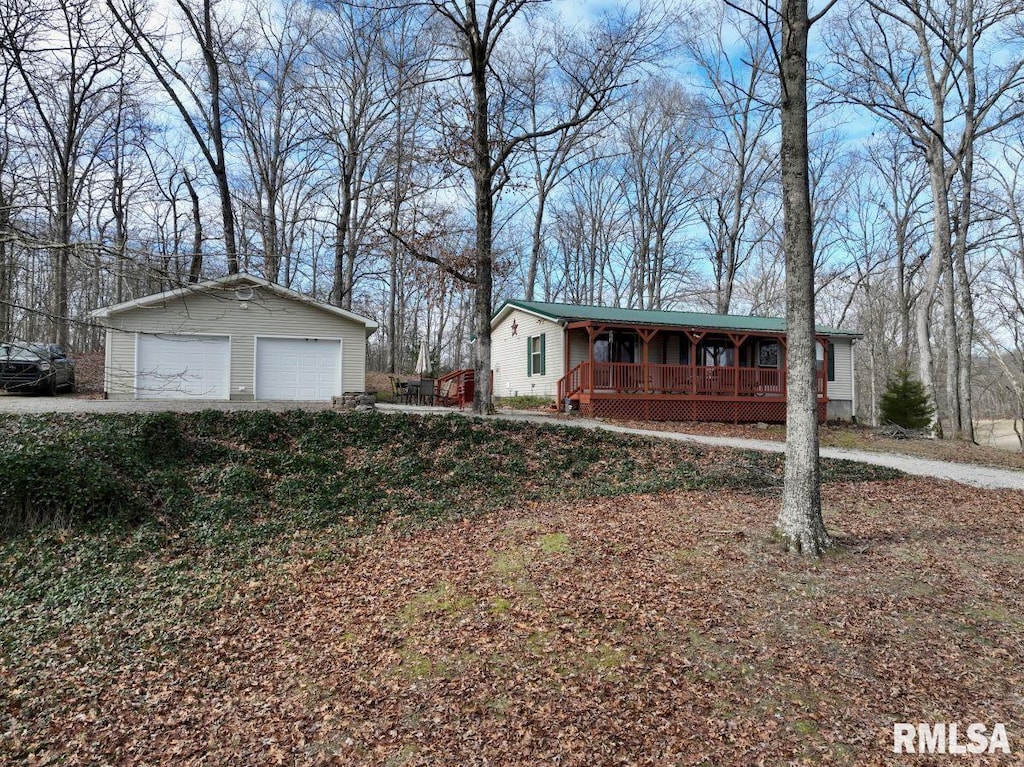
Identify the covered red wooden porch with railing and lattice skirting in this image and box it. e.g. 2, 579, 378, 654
558, 321, 829, 423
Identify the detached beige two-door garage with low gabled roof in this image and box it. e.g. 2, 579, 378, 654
92, 274, 377, 401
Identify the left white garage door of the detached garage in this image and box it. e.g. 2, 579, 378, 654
135, 335, 231, 399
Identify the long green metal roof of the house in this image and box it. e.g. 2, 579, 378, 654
493, 300, 861, 338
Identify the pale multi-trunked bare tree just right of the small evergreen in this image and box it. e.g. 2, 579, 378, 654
830, 0, 1024, 439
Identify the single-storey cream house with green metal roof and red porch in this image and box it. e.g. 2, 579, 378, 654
490, 300, 860, 423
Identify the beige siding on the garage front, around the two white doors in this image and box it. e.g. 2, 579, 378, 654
105, 286, 367, 400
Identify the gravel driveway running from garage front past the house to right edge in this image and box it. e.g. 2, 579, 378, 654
6, 392, 1024, 491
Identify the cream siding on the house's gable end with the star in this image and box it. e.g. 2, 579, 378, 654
490, 309, 565, 397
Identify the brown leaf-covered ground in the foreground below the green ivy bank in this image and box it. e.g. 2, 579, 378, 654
0, 415, 1024, 766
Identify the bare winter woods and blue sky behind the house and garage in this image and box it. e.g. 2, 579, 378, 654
0, 0, 1024, 437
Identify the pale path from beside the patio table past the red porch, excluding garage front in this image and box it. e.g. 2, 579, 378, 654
378, 404, 1024, 491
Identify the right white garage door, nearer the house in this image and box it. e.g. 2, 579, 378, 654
256, 338, 342, 401
